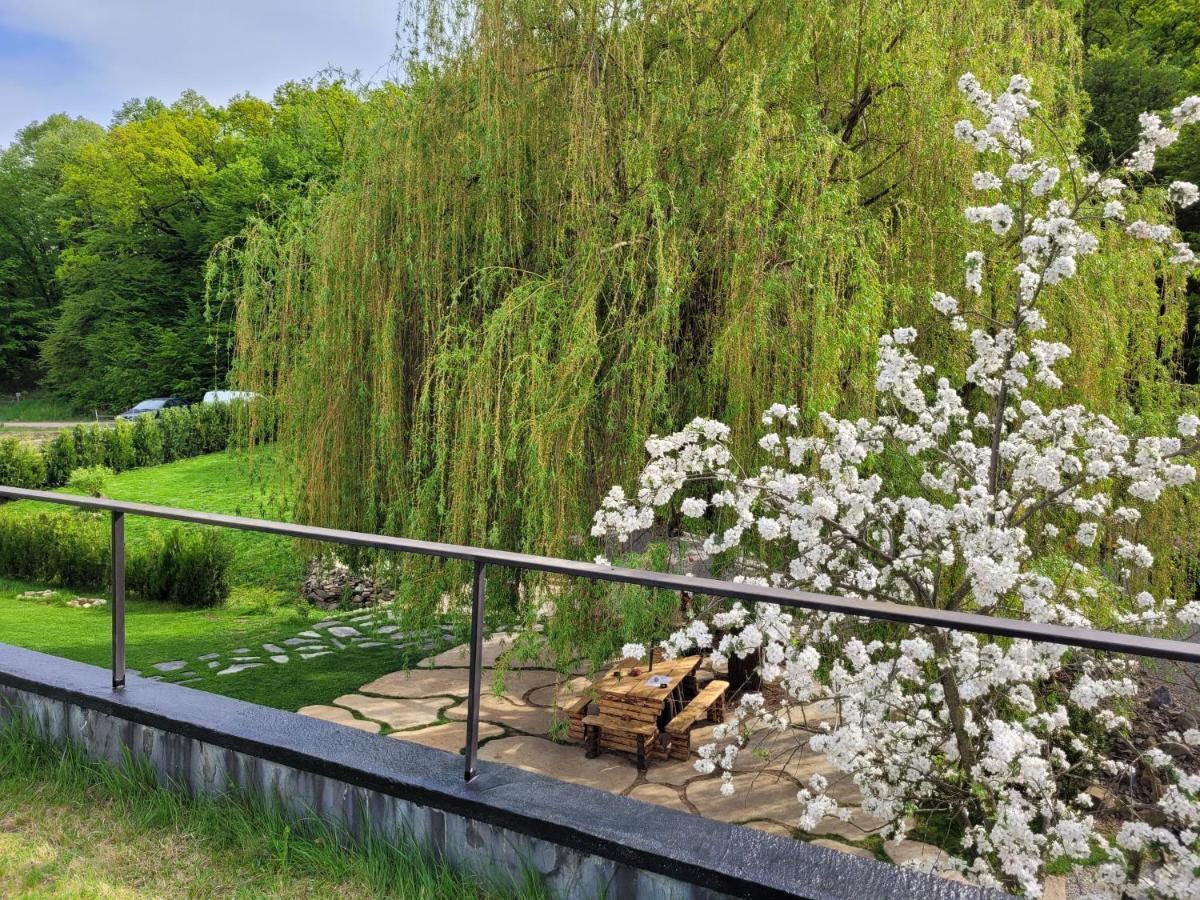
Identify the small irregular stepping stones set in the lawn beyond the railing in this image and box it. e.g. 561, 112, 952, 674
139, 609, 455, 686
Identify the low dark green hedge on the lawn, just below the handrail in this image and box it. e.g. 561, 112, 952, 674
0, 512, 233, 606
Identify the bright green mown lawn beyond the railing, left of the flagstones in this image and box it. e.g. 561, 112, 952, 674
0, 454, 458, 709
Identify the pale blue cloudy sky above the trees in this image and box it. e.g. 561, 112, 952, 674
0, 0, 397, 145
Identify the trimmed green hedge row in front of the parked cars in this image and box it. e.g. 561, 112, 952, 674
39, 403, 234, 487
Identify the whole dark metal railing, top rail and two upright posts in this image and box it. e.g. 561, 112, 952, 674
0, 485, 1200, 781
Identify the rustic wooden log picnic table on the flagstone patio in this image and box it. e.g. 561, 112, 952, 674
583, 656, 700, 772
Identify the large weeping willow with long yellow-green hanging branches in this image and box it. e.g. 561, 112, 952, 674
214, 0, 1200, 648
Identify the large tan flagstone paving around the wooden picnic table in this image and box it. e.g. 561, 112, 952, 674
292, 620, 956, 877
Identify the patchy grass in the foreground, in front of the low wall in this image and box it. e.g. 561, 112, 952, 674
0, 719, 544, 900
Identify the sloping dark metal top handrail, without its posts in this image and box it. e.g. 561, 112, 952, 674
0, 485, 1200, 662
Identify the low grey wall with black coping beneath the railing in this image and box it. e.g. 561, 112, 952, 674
0, 644, 997, 900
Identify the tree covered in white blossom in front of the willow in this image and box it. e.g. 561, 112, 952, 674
593, 74, 1200, 898
